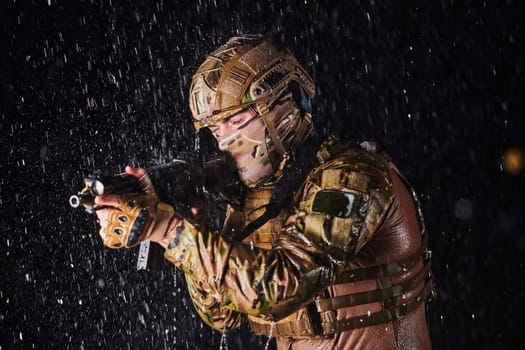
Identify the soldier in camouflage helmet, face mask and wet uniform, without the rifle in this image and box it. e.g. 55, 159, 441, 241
96, 36, 433, 350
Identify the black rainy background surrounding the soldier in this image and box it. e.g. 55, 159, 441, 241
0, 0, 525, 349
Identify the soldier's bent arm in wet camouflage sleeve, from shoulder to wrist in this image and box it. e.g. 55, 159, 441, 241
165, 149, 391, 329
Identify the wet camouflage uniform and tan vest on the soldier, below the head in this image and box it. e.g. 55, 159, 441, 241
165, 140, 432, 349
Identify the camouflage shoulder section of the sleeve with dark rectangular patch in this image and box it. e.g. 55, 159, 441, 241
296, 143, 392, 256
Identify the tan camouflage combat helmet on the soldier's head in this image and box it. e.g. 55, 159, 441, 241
190, 35, 315, 128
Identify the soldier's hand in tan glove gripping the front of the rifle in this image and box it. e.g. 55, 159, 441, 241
95, 166, 175, 248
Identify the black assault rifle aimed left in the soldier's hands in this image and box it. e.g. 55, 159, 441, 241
69, 153, 244, 271
